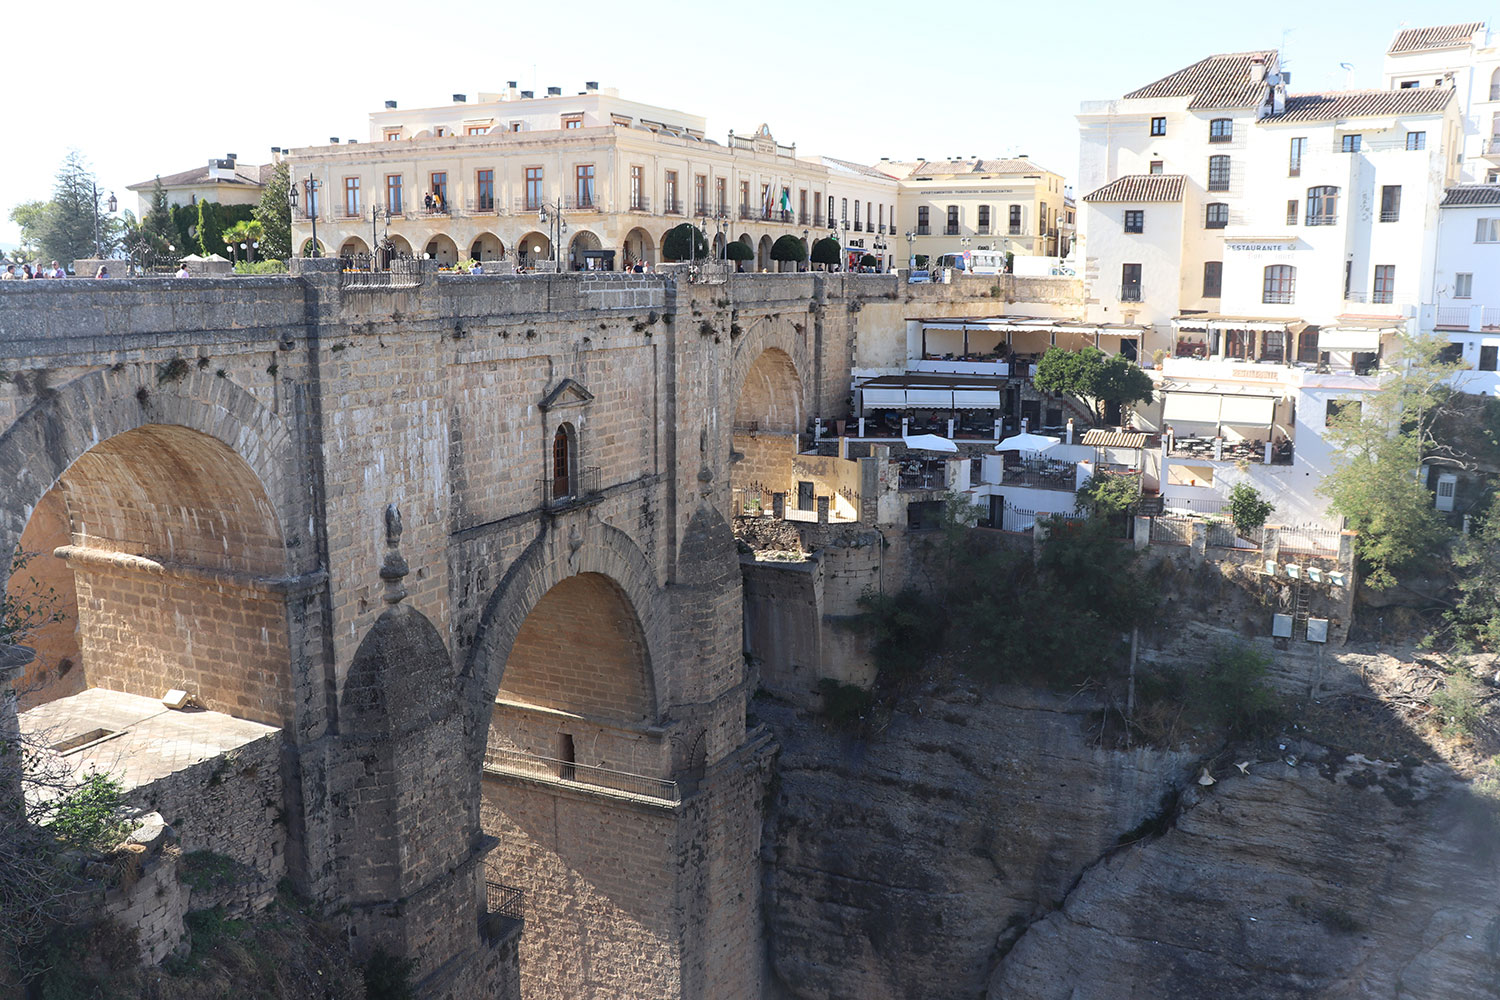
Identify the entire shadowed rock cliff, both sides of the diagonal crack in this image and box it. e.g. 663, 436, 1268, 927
756, 691, 1500, 1000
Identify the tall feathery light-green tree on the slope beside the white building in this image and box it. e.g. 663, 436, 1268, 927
1319, 336, 1463, 589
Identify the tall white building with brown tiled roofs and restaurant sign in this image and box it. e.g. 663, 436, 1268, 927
1079, 51, 1464, 525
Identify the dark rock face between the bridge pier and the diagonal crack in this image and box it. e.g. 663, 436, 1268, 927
756, 691, 1196, 1000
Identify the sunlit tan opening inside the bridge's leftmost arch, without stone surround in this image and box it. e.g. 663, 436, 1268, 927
6, 424, 294, 727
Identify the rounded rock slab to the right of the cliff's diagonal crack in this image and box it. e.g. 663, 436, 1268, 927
989, 748, 1500, 1000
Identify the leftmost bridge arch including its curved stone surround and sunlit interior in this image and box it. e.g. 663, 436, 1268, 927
0, 372, 296, 726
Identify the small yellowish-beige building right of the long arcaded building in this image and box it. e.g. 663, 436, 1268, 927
876, 156, 1071, 263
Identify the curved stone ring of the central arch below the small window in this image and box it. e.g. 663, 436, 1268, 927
464, 520, 674, 757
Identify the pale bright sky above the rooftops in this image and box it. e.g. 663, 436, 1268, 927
0, 0, 1496, 243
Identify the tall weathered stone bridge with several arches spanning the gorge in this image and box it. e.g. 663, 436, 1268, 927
0, 261, 1032, 999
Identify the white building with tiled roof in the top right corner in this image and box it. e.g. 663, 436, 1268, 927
1382, 21, 1500, 184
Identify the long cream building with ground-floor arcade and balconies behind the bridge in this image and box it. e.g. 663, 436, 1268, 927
288, 82, 897, 270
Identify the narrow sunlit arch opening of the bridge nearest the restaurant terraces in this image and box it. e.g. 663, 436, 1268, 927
729, 348, 804, 514
